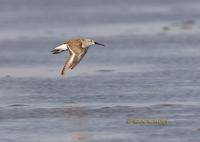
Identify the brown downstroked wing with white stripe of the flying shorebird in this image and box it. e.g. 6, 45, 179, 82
61, 48, 86, 75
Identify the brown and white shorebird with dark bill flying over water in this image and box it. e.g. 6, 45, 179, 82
51, 38, 104, 75
